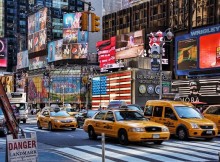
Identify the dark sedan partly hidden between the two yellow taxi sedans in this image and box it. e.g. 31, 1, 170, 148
75, 110, 98, 128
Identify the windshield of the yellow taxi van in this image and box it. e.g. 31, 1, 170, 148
175, 106, 203, 119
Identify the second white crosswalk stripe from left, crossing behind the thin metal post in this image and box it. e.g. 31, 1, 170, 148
75, 146, 147, 162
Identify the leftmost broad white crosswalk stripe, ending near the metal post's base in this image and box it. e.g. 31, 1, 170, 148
56, 147, 113, 162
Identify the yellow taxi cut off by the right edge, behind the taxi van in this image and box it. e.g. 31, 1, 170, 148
203, 105, 220, 133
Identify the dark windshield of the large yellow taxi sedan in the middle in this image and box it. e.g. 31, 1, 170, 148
115, 111, 146, 121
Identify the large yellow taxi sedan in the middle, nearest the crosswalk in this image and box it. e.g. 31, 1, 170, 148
83, 109, 170, 145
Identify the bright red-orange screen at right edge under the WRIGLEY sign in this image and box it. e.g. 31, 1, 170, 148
199, 33, 220, 69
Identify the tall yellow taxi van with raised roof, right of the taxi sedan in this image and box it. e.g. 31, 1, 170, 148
144, 100, 218, 140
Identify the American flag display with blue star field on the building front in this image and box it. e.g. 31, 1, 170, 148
92, 71, 132, 108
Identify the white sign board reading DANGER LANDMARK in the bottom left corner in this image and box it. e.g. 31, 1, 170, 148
7, 132, 38, 162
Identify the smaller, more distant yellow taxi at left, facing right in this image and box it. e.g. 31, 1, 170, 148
37, 107, 77, 131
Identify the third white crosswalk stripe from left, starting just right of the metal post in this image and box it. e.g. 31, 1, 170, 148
105, 145, 184, 162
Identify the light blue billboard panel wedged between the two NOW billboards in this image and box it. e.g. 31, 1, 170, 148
47, 39, 63, 62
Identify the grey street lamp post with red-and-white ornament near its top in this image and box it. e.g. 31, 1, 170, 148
147, 28, 174, 99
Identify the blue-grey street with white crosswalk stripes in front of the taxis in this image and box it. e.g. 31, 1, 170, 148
0, 117, 220, 162
